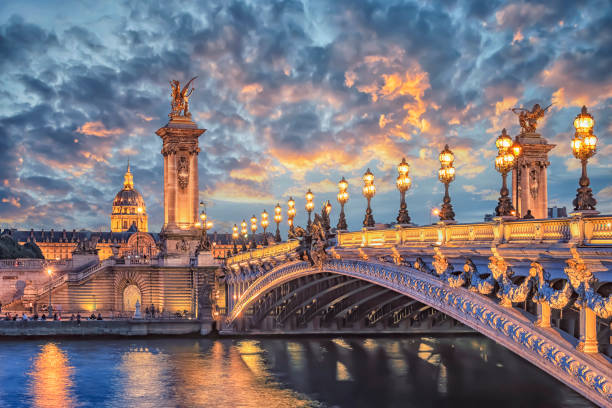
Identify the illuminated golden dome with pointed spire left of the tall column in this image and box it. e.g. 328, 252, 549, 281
111, 162, 149, 232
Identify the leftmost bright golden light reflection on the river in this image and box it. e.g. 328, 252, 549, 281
28, 343, 76, 408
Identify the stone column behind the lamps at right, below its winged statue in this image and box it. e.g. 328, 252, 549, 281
512, 133, 555, 218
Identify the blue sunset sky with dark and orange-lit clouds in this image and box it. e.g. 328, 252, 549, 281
0, 0, 612, 236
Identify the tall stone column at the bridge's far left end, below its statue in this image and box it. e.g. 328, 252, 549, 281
155, 116, 206, 263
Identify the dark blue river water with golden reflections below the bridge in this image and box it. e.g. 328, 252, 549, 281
0, 336, 591, 408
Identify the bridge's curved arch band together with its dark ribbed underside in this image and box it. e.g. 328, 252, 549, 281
226, 260, 612, 406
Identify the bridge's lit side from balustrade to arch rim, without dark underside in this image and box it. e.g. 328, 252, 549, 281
225, 216, 612, 405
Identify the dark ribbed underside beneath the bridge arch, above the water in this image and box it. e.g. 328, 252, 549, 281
237, 271, 473, 333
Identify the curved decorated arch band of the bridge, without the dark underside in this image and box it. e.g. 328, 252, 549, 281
226, 260, 612, 406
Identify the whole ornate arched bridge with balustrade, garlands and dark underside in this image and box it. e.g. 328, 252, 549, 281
222, 216, 612, 406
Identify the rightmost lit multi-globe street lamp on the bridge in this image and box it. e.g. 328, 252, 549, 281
572, 106, 597, 213
